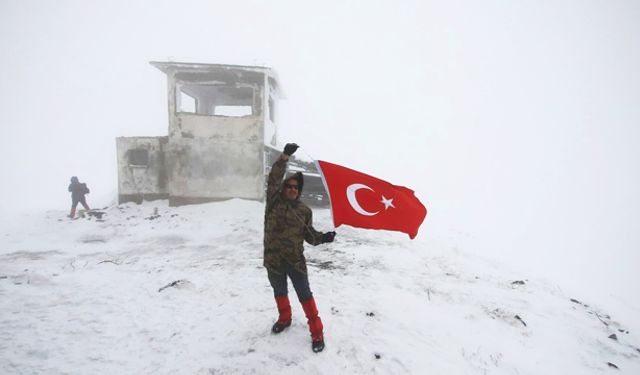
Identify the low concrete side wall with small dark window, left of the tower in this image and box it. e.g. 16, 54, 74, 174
116, 137, 169, 203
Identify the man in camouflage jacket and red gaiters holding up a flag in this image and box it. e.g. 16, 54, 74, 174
264, 143, 336, 352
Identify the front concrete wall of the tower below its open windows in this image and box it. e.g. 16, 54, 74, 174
167, 71, 265, 205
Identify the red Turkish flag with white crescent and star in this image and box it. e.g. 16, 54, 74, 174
316, 160, 427, 239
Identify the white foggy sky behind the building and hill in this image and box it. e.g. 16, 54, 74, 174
0, 0, 640, 318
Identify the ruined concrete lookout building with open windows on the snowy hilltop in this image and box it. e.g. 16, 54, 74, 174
116, 62, 324, 206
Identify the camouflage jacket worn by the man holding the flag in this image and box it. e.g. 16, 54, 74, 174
264, 159, 322, 273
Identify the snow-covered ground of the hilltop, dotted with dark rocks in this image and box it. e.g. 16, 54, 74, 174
0, 200, 640, 374
